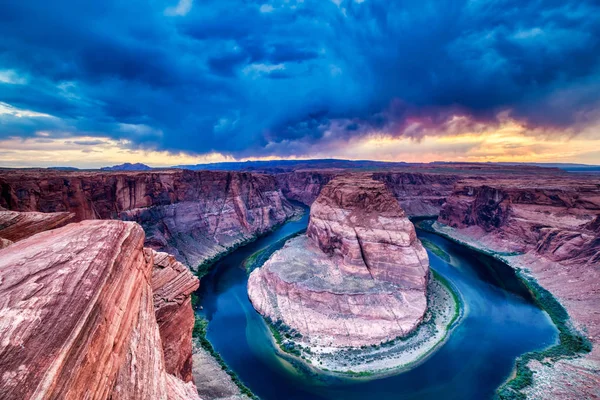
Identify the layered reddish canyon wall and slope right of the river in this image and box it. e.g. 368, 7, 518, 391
434, 177, 600, 398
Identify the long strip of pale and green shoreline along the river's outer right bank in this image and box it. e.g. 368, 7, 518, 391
418, 221, 600, 400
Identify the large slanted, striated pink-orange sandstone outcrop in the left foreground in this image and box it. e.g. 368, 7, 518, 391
0, 221, 198, 399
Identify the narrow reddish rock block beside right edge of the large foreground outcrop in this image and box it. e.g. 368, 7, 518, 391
146, 249, 200, 382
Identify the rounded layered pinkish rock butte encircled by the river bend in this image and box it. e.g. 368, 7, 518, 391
248, 175, 429, 347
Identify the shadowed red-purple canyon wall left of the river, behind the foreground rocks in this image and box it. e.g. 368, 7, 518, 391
0, 170, 298, 268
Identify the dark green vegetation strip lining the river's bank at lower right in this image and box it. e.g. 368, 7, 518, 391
498, 271, 592, 400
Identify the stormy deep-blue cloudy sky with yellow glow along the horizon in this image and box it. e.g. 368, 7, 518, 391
0, 0, 600, 168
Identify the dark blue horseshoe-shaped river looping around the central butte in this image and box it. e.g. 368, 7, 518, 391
197, 211, 557, 400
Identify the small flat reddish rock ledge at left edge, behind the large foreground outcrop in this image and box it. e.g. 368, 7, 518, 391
0, 210, 75, 244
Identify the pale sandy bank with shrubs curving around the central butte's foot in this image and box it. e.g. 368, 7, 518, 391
265, 270, 463, 379
